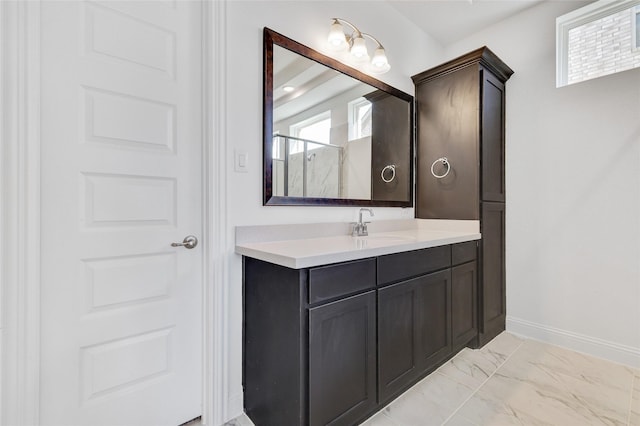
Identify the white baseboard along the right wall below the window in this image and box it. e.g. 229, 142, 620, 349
506, 316, 640, 369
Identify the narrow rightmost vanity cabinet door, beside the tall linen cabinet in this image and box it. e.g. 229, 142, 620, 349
451, 261, 478, 351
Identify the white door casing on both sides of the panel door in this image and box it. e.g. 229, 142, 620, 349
0, 1, 228, 426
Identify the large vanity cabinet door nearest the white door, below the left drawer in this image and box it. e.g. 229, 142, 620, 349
309, 291, 377, 426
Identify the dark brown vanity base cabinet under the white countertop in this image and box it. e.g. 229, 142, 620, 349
243, 241, 476, 426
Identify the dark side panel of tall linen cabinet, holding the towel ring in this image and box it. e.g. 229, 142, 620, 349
414, 66, 480, 220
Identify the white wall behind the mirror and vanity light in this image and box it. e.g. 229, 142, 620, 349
221, 1, 442, 418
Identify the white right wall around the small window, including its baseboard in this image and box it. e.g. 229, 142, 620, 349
445, 2, 640, 367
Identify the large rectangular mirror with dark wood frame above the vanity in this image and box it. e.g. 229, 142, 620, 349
263, 28, 413, 207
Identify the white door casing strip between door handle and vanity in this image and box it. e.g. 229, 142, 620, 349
202, 0, 229, 425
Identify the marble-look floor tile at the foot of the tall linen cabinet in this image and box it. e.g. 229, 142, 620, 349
437, 349, 502, 390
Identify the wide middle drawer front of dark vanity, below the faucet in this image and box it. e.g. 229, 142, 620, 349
378, 245, 451, 285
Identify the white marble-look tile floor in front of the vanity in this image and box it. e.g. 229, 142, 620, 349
227, 332, 640, 426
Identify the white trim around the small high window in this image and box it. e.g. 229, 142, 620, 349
556, 0, 640, 87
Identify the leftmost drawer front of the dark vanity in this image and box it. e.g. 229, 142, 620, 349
309, 259, 376, 304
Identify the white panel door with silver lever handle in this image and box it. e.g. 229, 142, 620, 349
40, 1, 203, 426
